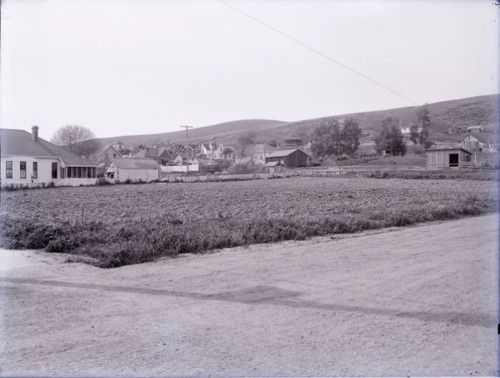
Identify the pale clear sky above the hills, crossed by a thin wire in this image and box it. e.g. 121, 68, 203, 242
0, 0, 500, 139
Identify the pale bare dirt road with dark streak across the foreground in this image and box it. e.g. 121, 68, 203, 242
0, 215, 498, 376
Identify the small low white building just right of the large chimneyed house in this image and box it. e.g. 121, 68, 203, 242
106, 158, 160, 182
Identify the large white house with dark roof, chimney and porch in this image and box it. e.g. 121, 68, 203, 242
0, 126, 97, 186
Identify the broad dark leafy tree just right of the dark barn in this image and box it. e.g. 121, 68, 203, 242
311, 118, 361, 157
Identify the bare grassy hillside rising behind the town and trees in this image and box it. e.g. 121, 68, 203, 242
94, 95, 499, 146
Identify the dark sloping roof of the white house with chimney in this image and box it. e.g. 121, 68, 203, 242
0, 129, 97, 167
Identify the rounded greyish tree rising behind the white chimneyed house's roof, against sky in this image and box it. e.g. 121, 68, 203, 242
50, 125, 100, 156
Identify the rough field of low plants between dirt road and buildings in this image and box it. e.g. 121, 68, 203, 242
0, 177, 497, 267
